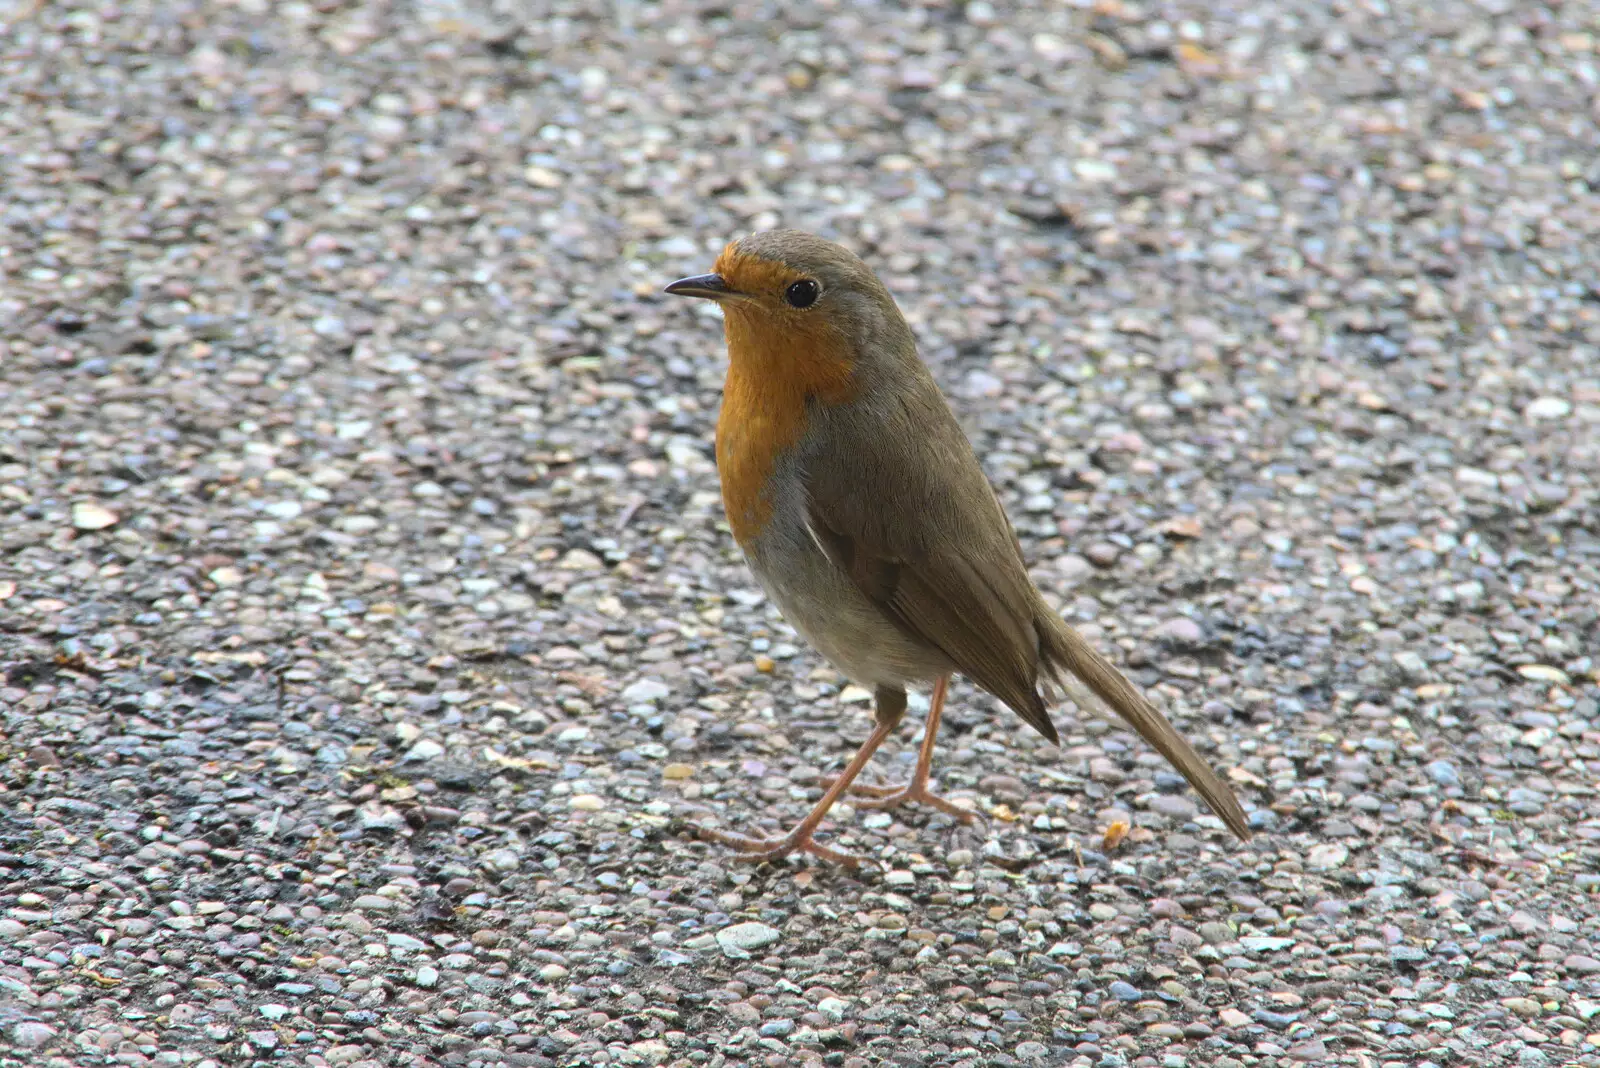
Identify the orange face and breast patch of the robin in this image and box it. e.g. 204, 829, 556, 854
715, 245, 854, 545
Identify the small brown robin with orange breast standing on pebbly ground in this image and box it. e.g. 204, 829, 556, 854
666, 230, 1250, 865
